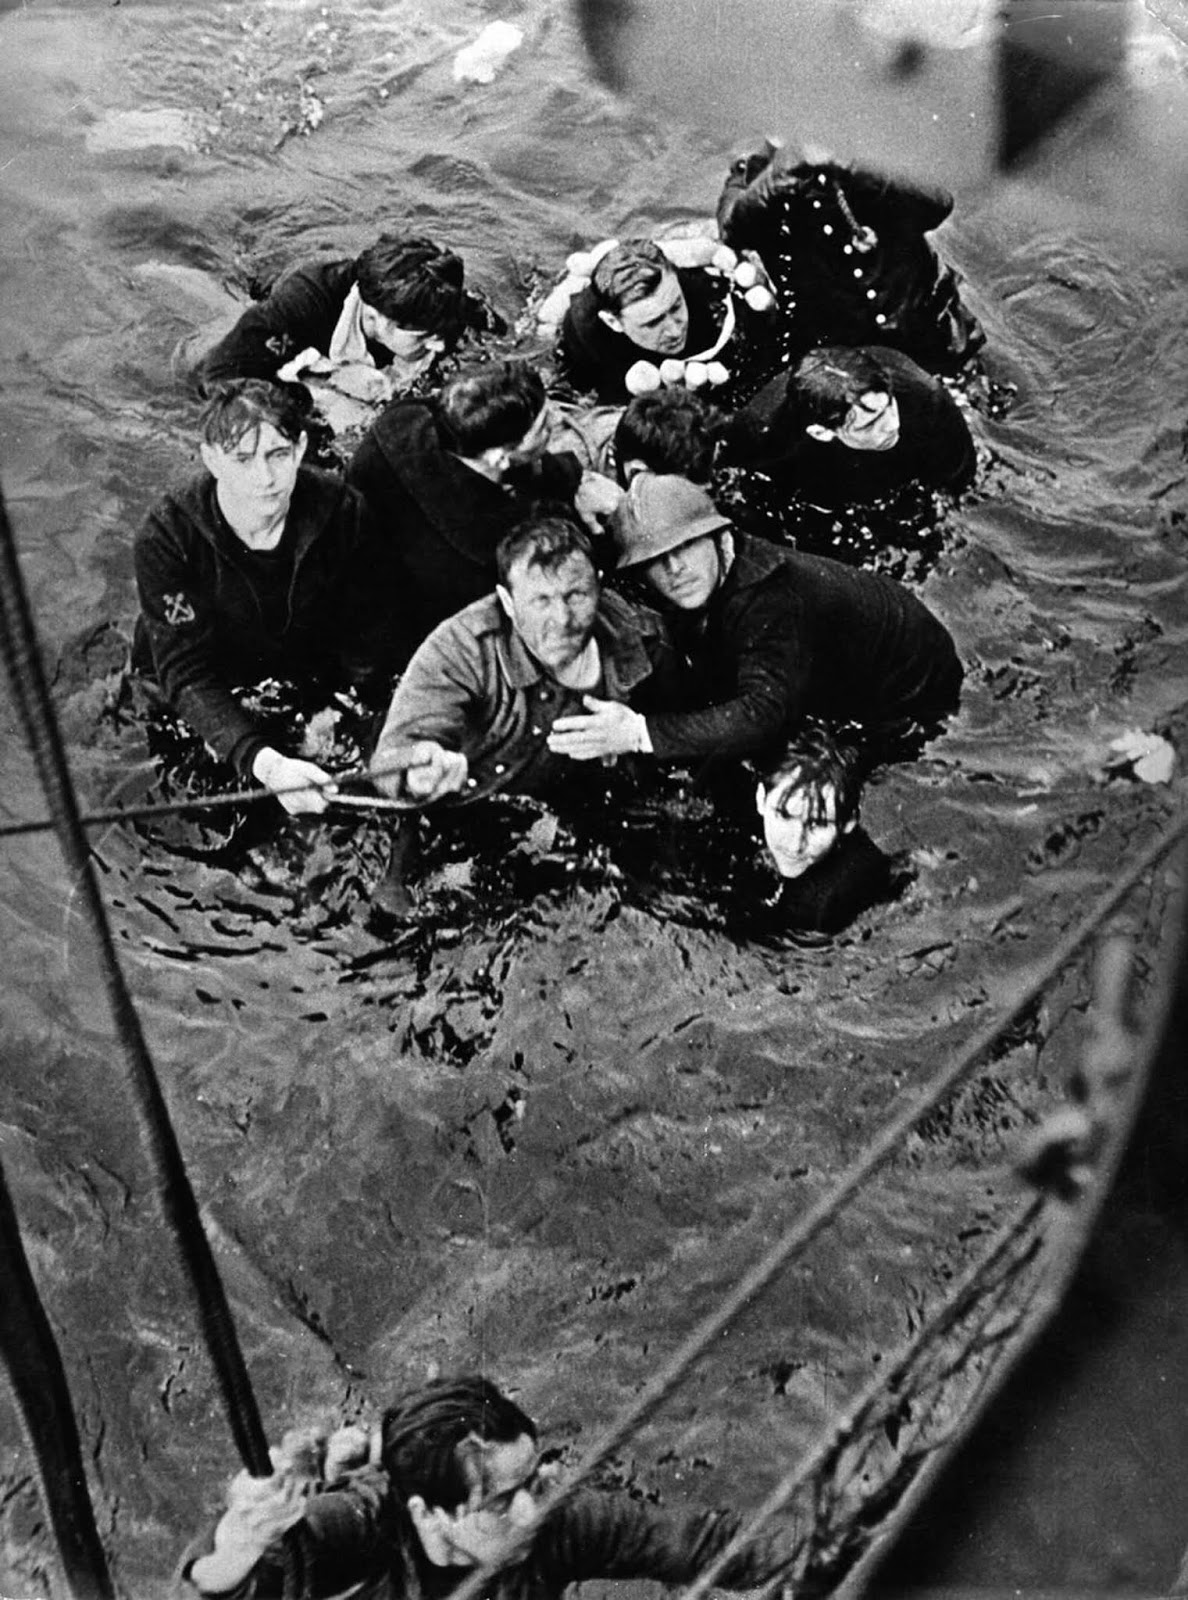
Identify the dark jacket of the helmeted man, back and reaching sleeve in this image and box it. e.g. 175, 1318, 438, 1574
647, 531, 962, 758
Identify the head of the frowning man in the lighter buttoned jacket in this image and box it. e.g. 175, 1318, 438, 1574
495, 514, 600, 674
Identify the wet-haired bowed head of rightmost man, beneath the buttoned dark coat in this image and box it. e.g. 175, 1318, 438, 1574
787, 346, 900, 451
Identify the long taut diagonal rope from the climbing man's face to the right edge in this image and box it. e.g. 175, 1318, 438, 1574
452, 813, 1188, 1600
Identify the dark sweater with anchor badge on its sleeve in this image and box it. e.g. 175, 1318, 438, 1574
133, 467, 399, 774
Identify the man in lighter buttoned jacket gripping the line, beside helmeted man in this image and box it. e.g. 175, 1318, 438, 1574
363, 514, 674, 912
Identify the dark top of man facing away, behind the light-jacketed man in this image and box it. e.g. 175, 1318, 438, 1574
346, 400, 581, 653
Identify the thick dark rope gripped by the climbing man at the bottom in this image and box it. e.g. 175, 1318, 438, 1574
0, 494, 312, 1587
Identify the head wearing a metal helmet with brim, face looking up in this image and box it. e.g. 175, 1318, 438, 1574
610, 472, 733, 611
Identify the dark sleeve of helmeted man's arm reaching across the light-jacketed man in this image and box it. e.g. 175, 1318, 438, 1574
647, 582, 810, 760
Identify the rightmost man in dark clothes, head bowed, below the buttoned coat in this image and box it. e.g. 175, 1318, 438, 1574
739, 346, 977, 507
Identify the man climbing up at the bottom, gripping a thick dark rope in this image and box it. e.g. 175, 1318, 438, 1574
183, 1376, 794, 1600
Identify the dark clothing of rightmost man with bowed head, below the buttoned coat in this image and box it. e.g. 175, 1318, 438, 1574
739, 346, 977, 507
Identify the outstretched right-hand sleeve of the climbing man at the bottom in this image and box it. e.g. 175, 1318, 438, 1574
535, 1493, 794, 1589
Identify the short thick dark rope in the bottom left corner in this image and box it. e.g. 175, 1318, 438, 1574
0, 1166, 115, 1600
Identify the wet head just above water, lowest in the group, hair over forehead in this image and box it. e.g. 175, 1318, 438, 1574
756, 725, 861, 878
